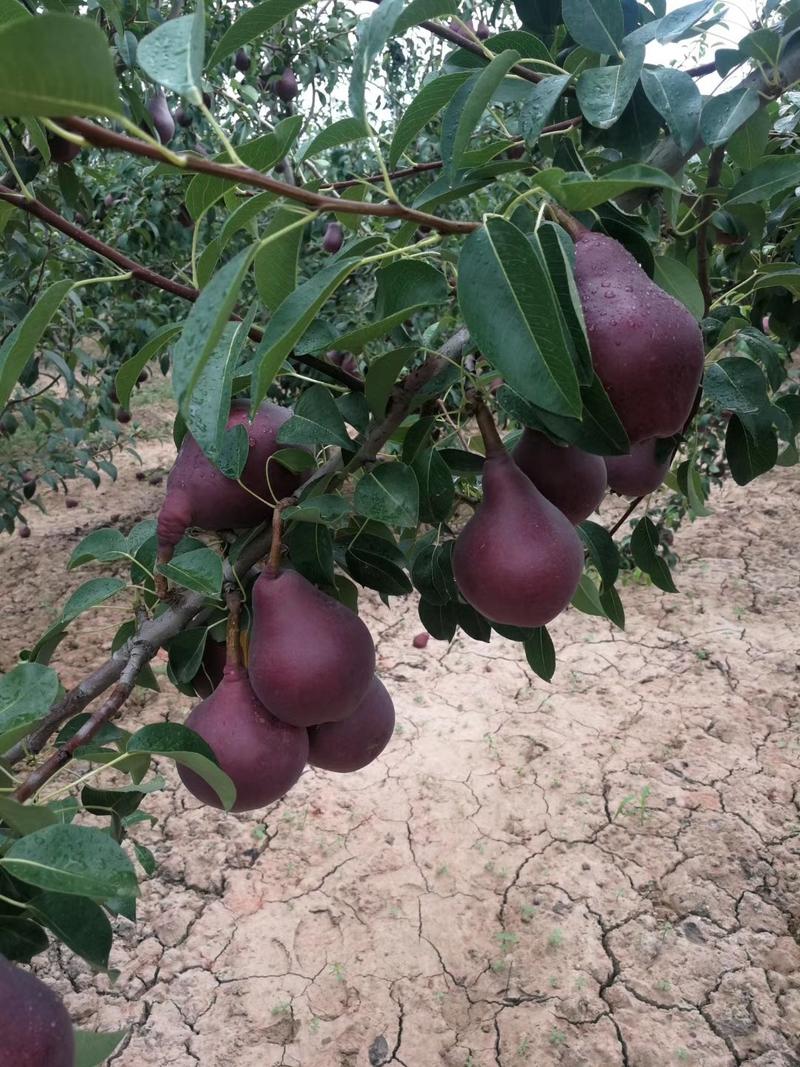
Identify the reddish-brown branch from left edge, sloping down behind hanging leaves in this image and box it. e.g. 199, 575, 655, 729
0, 185, 364, 392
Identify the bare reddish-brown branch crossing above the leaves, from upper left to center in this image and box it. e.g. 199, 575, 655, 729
63, 118, 480, 234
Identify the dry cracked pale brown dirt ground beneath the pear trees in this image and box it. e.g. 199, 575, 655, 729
0, 392, 800, 1067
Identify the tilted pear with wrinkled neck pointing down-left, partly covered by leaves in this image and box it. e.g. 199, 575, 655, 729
158, 401, 302, 550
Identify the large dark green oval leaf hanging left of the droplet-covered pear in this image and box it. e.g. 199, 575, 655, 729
459, 218, 581, 417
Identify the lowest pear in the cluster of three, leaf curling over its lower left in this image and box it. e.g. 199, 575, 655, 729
178, 667, 308, 811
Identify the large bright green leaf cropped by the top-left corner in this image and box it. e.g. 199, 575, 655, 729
0, 14, 122, 117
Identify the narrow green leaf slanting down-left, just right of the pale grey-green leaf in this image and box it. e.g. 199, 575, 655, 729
252, 258, 361, 411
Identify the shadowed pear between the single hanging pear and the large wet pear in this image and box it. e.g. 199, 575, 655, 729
511, 429, 606, 525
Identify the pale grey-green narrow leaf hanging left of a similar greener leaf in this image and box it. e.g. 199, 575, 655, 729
172, 244, 257, 412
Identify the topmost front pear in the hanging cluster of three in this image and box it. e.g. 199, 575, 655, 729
247, 568, 375, 727
